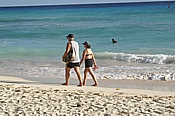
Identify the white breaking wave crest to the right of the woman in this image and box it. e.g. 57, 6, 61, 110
95, 52, 175, 64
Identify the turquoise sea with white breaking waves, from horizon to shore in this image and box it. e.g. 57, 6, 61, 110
0, 1, 175, 79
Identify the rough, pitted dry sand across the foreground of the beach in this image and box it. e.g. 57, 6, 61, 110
0, 84, 175, 116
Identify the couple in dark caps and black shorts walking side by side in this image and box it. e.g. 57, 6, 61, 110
62, 34, 98, 86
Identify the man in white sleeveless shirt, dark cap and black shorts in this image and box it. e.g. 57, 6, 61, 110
62, 34, 83, 86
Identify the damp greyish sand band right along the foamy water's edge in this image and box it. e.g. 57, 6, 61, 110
0, 76, 175, 92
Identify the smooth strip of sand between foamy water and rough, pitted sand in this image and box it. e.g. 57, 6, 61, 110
0, 76, 175, 96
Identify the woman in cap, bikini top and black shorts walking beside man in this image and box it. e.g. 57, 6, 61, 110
80, 41, 98, 86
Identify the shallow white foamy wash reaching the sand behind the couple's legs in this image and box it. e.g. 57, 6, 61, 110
0, 59, 175, 81
